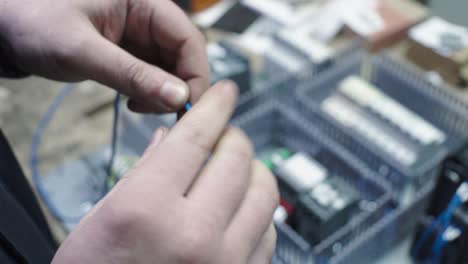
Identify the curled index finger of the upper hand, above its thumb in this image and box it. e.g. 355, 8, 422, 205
151, 1, 210, 103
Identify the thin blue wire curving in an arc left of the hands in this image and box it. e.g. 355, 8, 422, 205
29, 84, 80, 222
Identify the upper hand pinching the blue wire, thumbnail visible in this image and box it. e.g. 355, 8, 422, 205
0, 0, 209, 112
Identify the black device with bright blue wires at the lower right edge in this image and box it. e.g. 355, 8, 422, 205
411, 147, 468, 264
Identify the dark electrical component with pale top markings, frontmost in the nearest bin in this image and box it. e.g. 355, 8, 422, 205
295, 177, 359, 244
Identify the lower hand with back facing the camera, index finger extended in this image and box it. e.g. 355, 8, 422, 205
53, 82, 279, 264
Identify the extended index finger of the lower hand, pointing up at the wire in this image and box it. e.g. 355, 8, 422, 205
134, 81, 238, 195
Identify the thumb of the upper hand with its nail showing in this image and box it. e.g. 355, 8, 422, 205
70, 33, 190, 112
